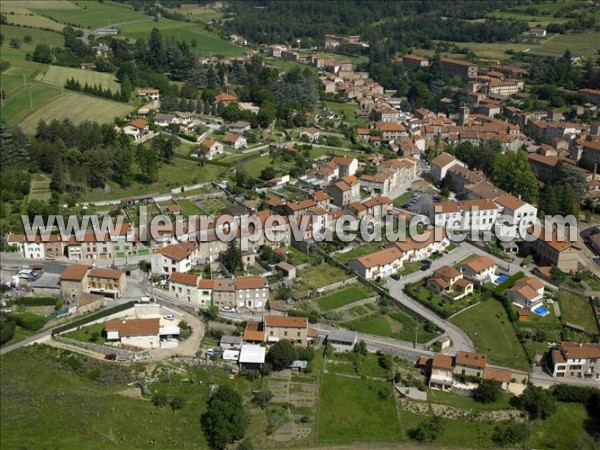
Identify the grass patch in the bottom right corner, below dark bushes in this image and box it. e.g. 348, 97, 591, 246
527, 403, 600, 449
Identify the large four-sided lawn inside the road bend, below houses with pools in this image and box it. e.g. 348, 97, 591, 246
451, 299, 529, 370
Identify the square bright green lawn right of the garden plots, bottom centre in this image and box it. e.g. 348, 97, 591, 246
317, 374, 399, 443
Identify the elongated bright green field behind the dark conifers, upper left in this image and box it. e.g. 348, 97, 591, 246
119, 19, 244, 56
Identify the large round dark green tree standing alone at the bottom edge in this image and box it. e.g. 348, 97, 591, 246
200, 386, 250, 450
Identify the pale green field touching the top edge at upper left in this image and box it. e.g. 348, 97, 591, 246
29, 1, 150, 28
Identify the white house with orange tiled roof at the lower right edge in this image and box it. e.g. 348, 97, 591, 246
550, 342, 600, 380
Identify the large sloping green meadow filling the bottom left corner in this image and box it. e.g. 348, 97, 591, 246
0, 345, 252, 449
